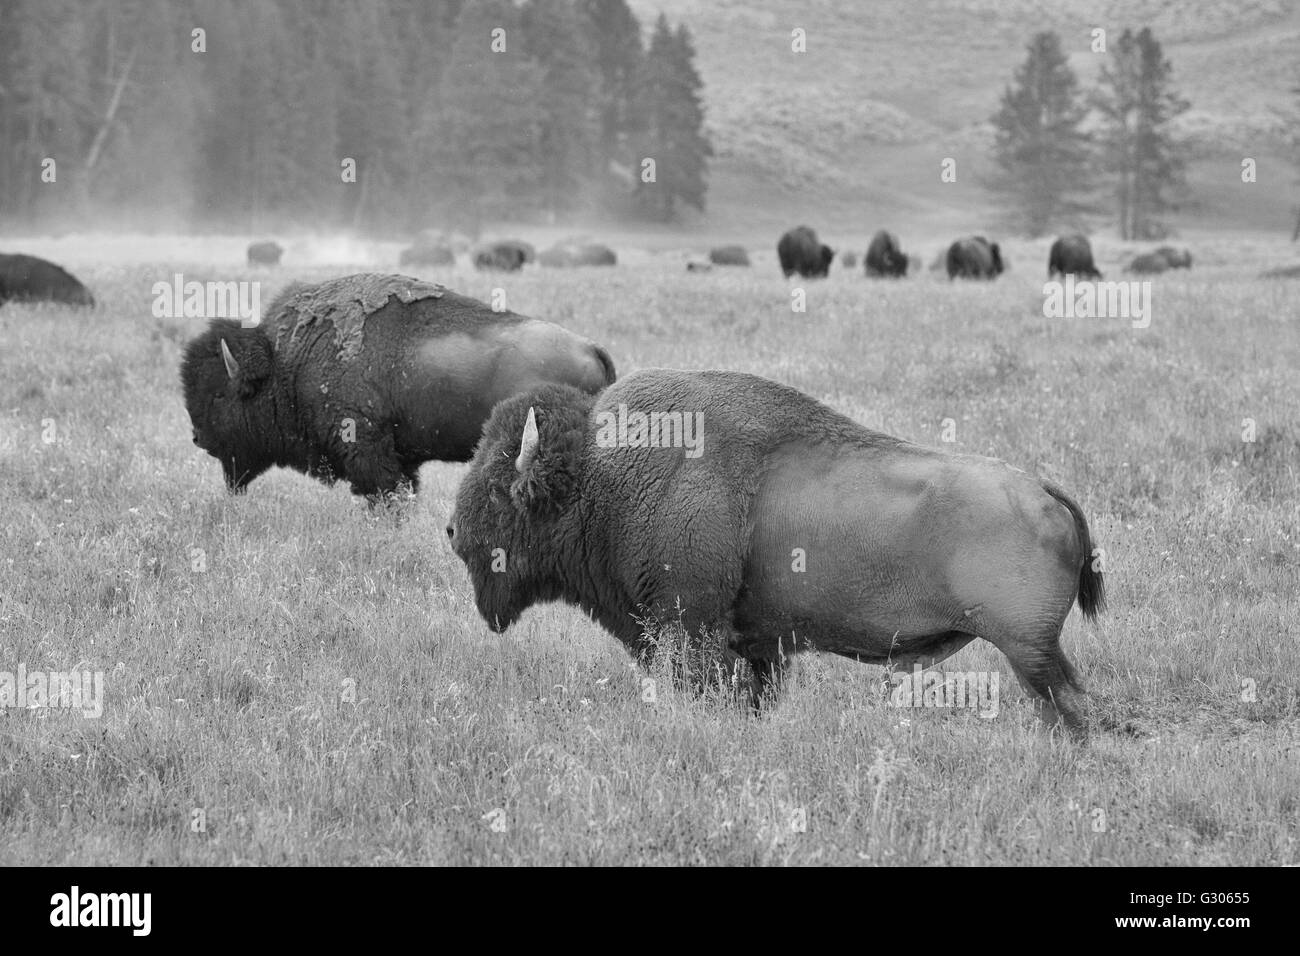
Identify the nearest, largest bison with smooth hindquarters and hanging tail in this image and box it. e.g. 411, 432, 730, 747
447, 368, 1102, 728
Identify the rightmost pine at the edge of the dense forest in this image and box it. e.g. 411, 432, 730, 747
636, 14, 714, 221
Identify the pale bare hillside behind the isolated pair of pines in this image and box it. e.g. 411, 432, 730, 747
631, 0, 1300, 233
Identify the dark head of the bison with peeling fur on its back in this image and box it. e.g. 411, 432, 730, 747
181, 319, 276, 492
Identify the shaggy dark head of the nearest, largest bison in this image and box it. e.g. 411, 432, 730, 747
447, 385, 595, 631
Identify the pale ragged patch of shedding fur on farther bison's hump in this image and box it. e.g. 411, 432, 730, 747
272, 273, 447, 360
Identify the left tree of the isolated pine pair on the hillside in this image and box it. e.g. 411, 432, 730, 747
993, 33, 1091, 237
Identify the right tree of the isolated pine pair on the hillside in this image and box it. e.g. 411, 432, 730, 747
1096, 27, 1190, 239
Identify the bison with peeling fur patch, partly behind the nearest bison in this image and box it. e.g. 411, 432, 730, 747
181, 274, 615, 496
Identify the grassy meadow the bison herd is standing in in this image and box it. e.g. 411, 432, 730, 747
0, 250, 1300, 864
